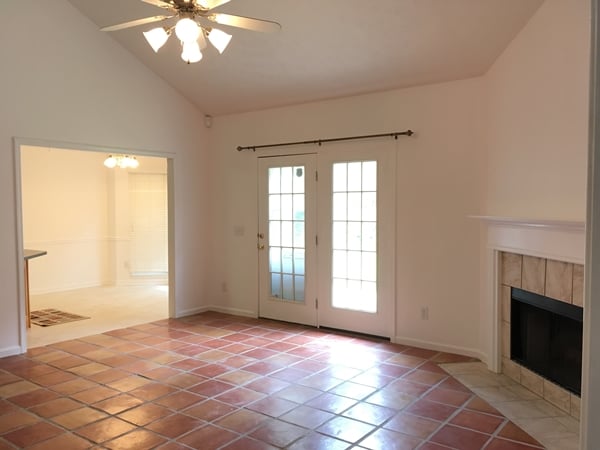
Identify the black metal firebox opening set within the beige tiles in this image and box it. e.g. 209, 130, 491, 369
510, 287, 583, 395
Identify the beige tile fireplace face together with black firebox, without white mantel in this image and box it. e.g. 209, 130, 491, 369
499, 252, 583, 417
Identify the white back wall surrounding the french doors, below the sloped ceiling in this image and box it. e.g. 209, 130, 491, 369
210, 79, 483, 353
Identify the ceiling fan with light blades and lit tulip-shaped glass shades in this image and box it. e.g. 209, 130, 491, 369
101, 0, 281, 64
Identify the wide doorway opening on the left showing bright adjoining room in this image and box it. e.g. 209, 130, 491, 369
17, 143, 174, 350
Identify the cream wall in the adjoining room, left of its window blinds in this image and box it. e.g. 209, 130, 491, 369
21, 146, 110, 295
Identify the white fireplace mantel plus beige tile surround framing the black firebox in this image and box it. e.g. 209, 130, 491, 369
474, 216, 585, 419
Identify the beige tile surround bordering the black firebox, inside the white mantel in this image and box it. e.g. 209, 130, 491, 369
498, 251, 583, 419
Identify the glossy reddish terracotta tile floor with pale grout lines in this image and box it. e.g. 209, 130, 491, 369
0, 313, 542, 450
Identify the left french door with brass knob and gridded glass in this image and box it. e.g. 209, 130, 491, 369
256, 155, 318, 326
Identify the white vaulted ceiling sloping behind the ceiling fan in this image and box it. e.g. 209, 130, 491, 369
69, 0, 543, 116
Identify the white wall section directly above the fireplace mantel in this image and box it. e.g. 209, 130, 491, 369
485, 0, 590, 221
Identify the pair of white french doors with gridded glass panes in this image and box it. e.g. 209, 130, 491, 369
257, 143, 395, 337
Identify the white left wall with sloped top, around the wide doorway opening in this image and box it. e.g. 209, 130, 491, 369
0, 0, 209, 355
